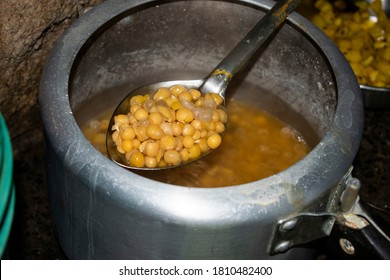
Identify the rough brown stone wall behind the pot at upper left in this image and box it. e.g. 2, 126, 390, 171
0, 0, 103, 155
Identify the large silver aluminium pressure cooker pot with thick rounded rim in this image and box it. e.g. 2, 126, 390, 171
40, 0, 363, 259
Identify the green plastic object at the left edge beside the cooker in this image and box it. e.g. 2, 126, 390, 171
0, 113, 15, 258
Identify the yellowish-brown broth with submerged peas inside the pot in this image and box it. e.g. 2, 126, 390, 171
82, 100, 310, 188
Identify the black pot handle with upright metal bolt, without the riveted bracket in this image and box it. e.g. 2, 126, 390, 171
328, 178, 390, 259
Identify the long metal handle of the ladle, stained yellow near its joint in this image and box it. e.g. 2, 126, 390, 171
199, 0, 300, 99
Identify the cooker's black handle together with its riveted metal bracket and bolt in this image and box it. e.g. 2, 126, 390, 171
269, 172, 390, 259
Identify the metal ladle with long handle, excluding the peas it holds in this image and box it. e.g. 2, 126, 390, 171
106, 0, 300, 170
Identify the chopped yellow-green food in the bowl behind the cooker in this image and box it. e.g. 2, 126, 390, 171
311, 0, 390, 88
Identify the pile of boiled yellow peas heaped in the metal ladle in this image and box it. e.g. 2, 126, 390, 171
111, 85, 227, 168
